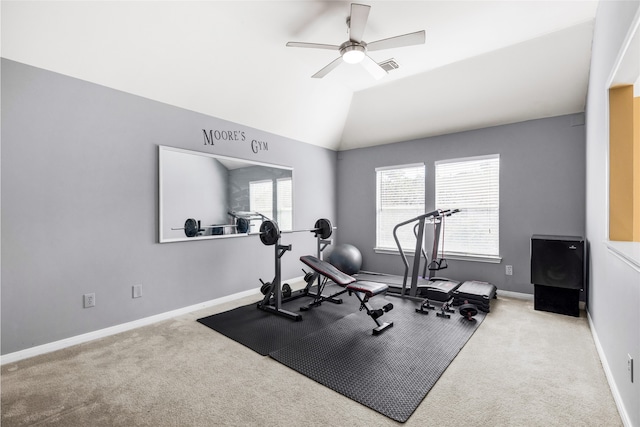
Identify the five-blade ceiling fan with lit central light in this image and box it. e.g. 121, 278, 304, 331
287, 3, 425, 79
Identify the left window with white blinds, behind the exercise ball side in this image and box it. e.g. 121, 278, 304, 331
376, 164, 425, 250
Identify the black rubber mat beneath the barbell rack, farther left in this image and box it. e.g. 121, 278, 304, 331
198, 284, 360, 356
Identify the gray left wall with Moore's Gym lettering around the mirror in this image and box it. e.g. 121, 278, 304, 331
1, 59, 336, 354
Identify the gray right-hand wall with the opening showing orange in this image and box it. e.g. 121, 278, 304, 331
586, 1, 640, 426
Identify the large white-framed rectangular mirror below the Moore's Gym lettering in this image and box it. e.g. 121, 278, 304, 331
158, 146, 293, 243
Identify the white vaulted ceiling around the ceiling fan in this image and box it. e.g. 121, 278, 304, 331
0, 0, 597, 150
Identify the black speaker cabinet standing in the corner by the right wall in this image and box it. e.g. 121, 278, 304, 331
531, 234, 586, 316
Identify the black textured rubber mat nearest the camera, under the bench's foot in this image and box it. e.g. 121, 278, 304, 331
269, 296, 485, 422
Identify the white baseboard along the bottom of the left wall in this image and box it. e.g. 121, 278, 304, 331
0, 289, 260, 365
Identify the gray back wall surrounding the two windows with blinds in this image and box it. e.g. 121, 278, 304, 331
338, 114, 585, 294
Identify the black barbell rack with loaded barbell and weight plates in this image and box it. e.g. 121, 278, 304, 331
257, 218, 342, 321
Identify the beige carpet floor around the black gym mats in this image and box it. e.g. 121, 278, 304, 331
1, 295, 622, 427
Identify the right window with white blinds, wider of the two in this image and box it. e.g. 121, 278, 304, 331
435, 154, 500, 258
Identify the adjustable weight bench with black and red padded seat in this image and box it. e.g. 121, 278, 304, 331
300, 255, 393, 335
